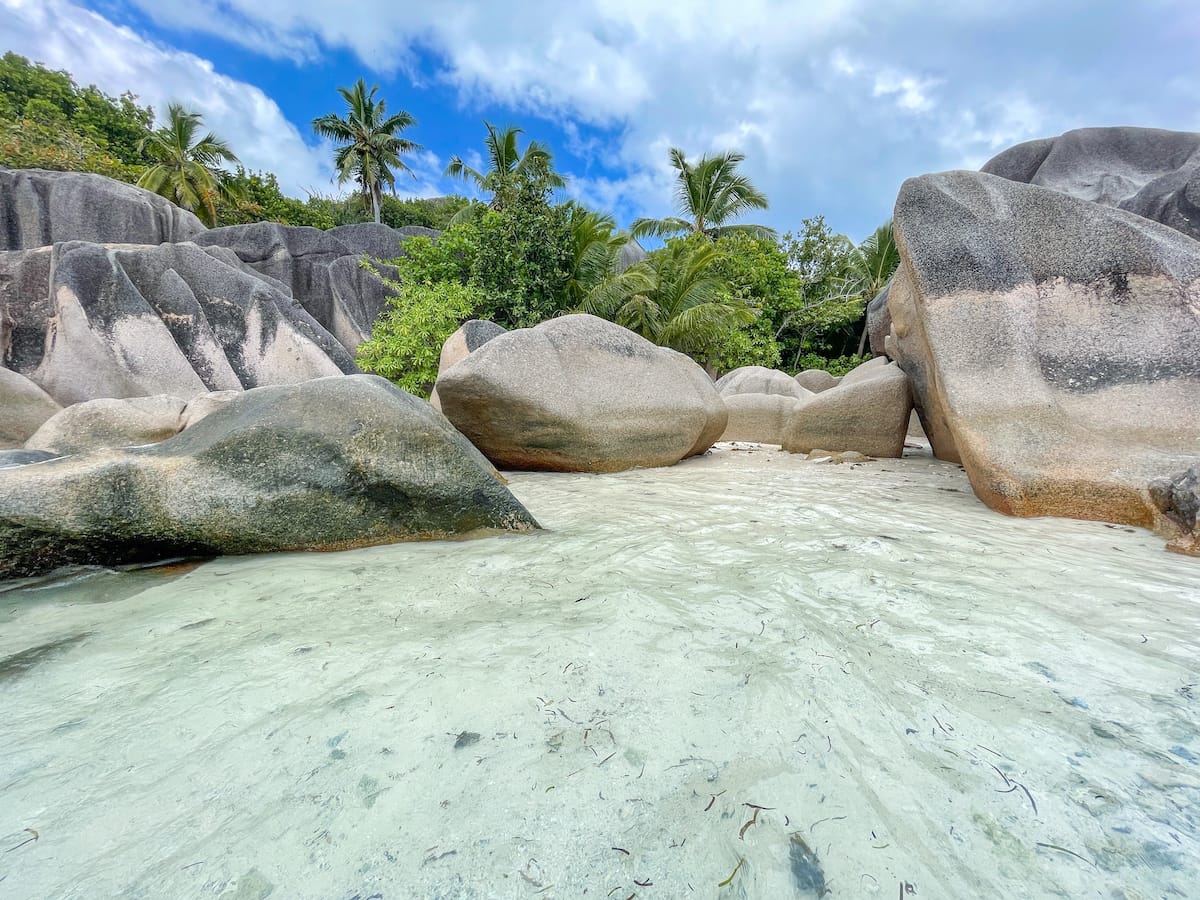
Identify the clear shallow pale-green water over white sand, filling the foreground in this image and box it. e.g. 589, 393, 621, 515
0, 451, 1200, 900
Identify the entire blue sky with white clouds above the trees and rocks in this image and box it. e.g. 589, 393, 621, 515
0, 0, 1200, 240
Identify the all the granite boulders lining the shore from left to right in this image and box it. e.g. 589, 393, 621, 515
0, 121, 1200, 577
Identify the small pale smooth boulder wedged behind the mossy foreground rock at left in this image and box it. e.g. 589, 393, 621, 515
25, 394, 187, 456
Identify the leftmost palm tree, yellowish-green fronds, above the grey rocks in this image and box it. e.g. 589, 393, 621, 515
138, 103, 242, 227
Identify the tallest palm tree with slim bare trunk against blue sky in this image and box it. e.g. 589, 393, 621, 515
312, 78, 421, 222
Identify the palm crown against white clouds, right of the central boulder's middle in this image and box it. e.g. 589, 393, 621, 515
630, 148, 775, 238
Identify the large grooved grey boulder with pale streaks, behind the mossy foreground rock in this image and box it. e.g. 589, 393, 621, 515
0, 241, 359, 406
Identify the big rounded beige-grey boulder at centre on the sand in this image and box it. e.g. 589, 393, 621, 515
437, 316, 727, 472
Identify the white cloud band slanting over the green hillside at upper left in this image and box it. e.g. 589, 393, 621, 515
0, 0, 332, 197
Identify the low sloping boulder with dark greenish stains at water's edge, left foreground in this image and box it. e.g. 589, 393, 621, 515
0, 376, 538, 577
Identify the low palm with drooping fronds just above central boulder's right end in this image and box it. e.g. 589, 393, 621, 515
580, 241, 757, 364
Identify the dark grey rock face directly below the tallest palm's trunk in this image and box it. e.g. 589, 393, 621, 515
196, 222, 427, 353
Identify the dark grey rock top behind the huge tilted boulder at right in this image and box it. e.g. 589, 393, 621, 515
983, 127, 1200, 239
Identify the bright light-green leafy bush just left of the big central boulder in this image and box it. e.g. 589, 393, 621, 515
355, 281, 482, 397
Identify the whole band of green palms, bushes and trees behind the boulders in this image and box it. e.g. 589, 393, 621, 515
0, 53, 899, 384
